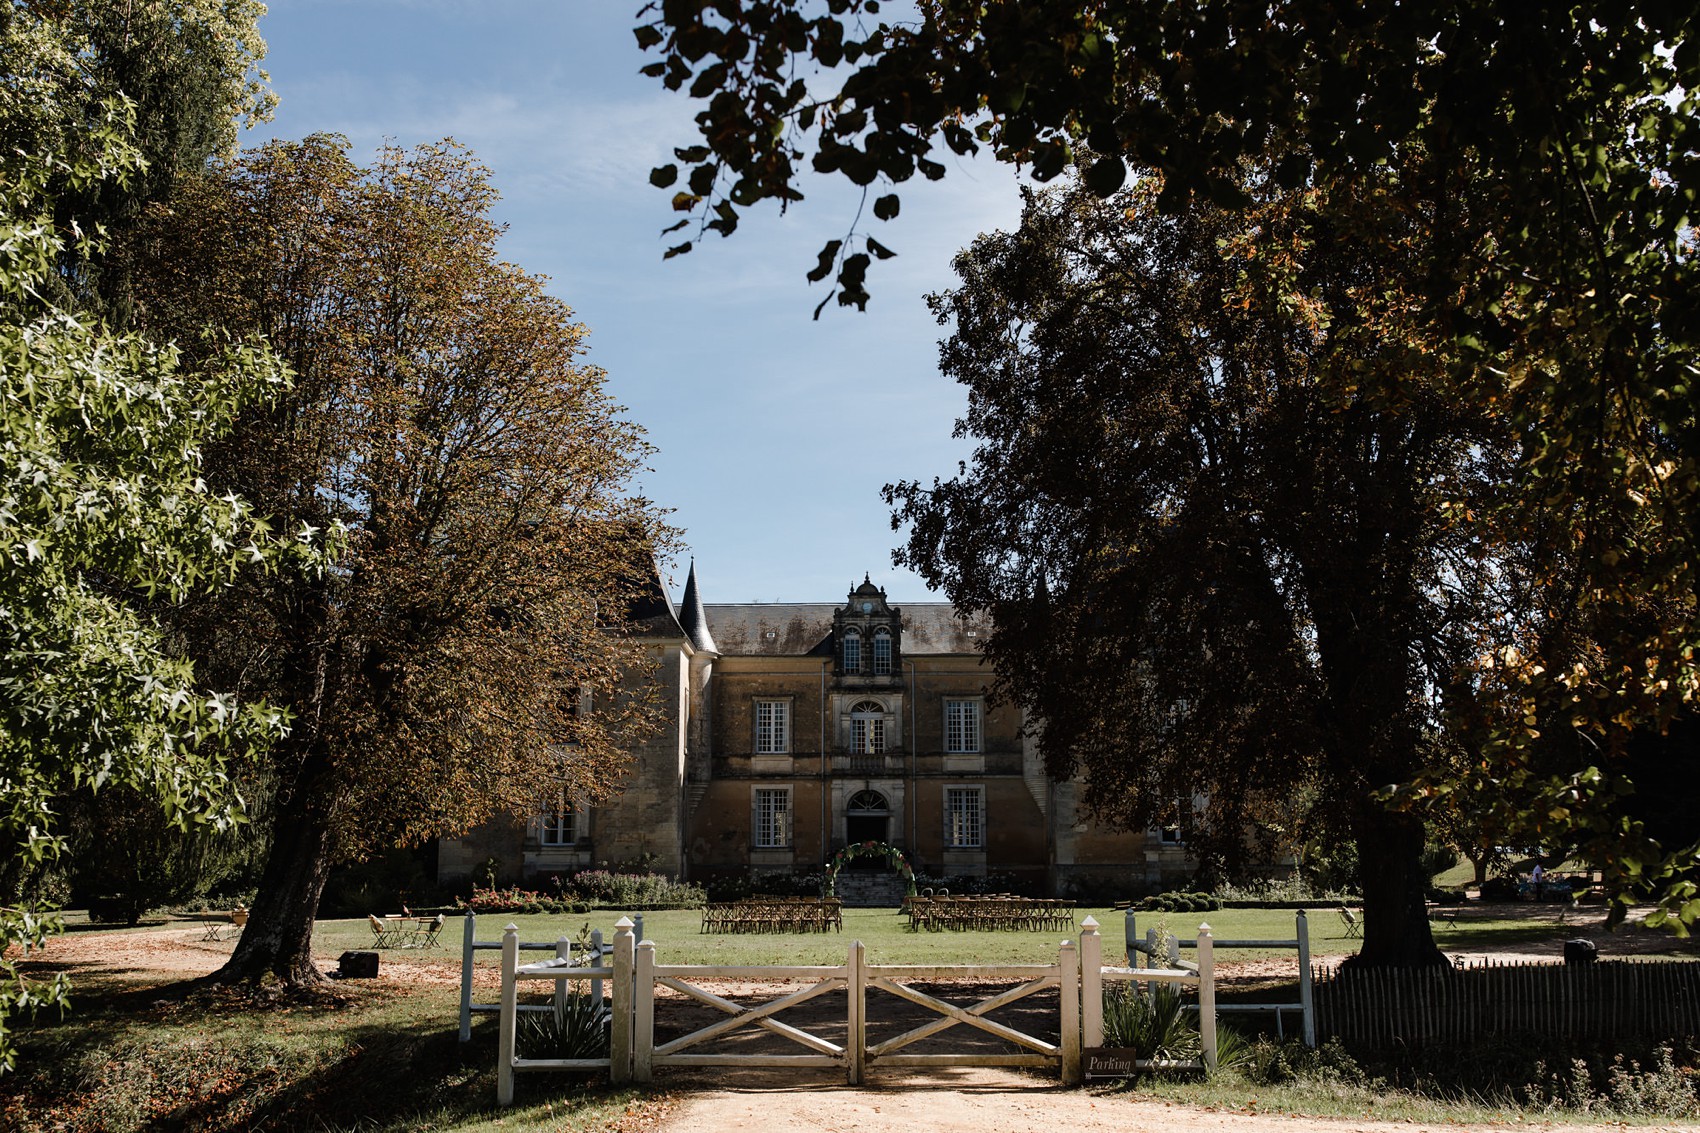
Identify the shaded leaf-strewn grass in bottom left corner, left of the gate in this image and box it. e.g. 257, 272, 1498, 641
0, 982, 636, 1133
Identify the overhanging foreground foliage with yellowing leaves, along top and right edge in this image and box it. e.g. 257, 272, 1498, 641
636, 0, 1700, 919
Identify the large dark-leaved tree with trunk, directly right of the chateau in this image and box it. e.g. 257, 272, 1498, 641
887, 177, 1515, 966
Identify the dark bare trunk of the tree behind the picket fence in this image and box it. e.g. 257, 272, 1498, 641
1348, 800, 1448, 968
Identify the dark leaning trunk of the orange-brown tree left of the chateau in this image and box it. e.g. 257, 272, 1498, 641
211, 772, 332, 987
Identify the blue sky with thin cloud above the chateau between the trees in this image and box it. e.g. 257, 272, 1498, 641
243, 0, 1020, 602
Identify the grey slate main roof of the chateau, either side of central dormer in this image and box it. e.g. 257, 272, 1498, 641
702, 602, 989, 657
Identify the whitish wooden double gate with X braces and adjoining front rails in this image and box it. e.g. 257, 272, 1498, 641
496, 917, 1216, 1106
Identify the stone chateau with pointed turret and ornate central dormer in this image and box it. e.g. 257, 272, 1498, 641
439, 565, 1192, 897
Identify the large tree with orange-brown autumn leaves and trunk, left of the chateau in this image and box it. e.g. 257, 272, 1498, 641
136, 138, 665, 985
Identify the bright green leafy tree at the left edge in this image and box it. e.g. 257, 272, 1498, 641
0, 3, 318, 1068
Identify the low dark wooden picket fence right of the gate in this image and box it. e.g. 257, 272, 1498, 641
1314, 959, 1700, 1050
